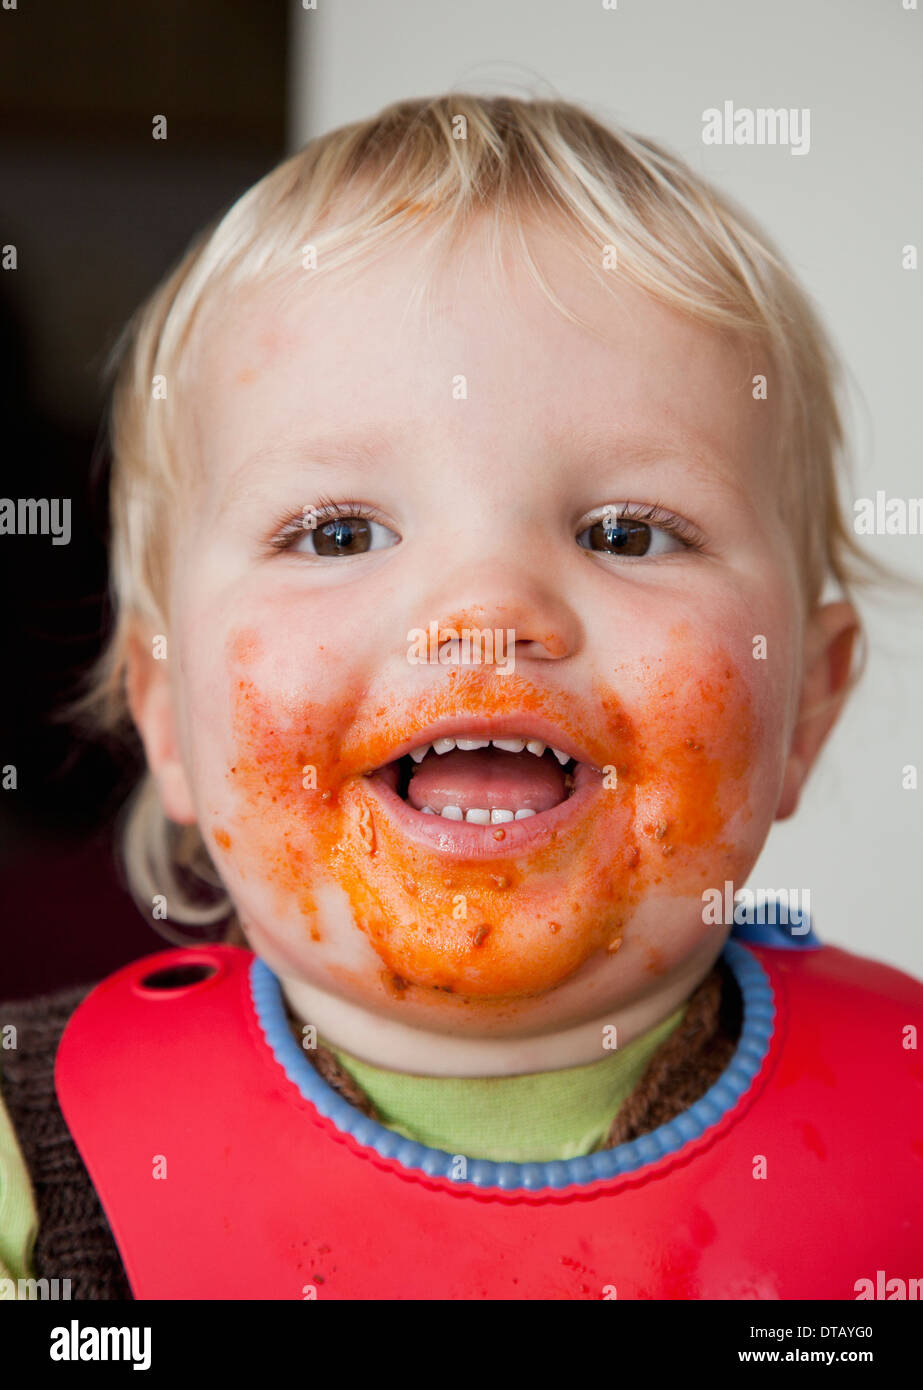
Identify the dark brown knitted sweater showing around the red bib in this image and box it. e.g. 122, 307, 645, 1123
0, 962, 741, 1300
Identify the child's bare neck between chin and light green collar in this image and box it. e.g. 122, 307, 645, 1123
278, 958, 714, 1077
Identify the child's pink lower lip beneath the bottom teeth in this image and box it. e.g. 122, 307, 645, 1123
366, 766, 602, 860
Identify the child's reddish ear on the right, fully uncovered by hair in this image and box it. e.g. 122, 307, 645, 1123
776, 602, 859, 820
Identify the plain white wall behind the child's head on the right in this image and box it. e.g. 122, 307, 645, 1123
291, 0, 923, 977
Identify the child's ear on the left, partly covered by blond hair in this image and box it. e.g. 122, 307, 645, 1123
125, 632, 197, 826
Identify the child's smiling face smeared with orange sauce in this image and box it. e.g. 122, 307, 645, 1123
129, 216, 850, 1036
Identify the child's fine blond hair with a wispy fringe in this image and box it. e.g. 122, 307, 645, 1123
81, 93, 880, 940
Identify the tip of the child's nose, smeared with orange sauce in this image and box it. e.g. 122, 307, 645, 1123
420, 562, 582, 662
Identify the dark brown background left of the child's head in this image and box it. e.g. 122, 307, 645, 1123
0, 0, 288, 998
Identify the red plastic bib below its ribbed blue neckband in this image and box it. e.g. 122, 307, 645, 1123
56, 947, 923, 1300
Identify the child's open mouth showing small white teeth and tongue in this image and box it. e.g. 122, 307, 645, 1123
370, 733, 598, 826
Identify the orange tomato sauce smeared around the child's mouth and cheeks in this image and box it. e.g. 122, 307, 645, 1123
225, 631, 756, 1001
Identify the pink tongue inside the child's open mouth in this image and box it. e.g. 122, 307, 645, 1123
407, 748, 566, 812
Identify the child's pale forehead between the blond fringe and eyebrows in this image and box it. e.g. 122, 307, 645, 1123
190, 229, 774, 503
